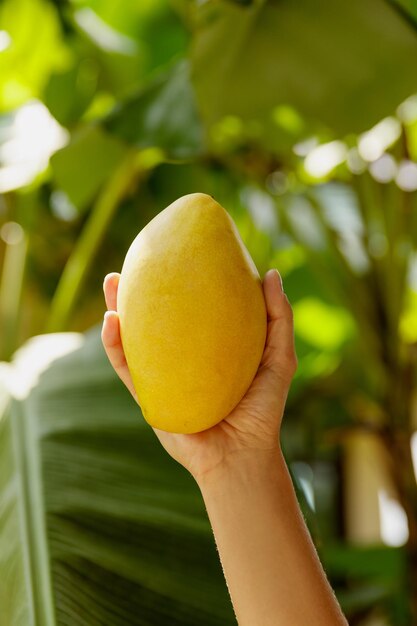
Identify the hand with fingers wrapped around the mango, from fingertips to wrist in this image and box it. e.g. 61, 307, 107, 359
102, 270, 297, 482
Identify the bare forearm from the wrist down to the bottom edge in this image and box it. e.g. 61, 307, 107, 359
198, 449, 346, 626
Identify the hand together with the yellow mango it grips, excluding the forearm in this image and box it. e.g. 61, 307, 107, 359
102, 194, 296, 475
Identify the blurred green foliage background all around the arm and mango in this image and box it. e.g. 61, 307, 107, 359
0, 0, 417, 626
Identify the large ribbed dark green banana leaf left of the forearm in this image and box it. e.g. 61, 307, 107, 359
0, 331, 236, 626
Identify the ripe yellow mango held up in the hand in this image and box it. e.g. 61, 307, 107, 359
117, 193, 267, 433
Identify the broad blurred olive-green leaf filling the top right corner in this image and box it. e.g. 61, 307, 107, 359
192, 0, 417, 138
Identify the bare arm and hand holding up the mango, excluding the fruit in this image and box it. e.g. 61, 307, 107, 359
102, 270, 347, 626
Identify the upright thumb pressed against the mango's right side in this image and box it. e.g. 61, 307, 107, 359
261, 270, 297, 383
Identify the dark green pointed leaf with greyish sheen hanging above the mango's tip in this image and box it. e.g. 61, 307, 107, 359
104, 61, 204, 159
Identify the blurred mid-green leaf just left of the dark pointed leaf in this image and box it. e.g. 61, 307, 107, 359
51, 126, 127, 210
